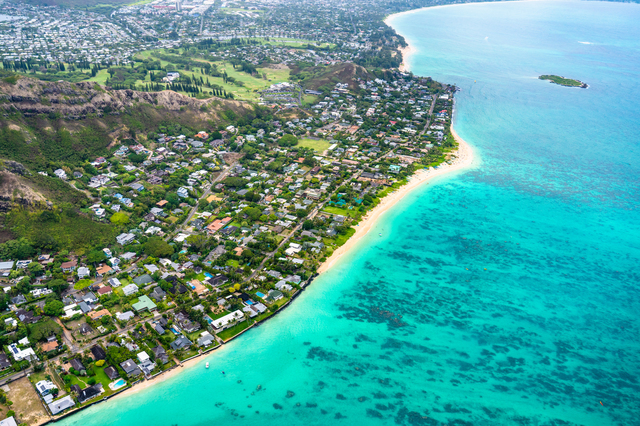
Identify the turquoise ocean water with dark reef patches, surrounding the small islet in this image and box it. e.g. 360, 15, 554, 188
60, 2, 640, 426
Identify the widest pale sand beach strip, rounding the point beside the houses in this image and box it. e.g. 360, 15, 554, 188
318, 131, 473, 273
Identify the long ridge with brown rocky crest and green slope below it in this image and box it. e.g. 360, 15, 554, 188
0, 77, 254, 171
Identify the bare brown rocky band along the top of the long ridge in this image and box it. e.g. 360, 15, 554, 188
0, 77, 246, 120
